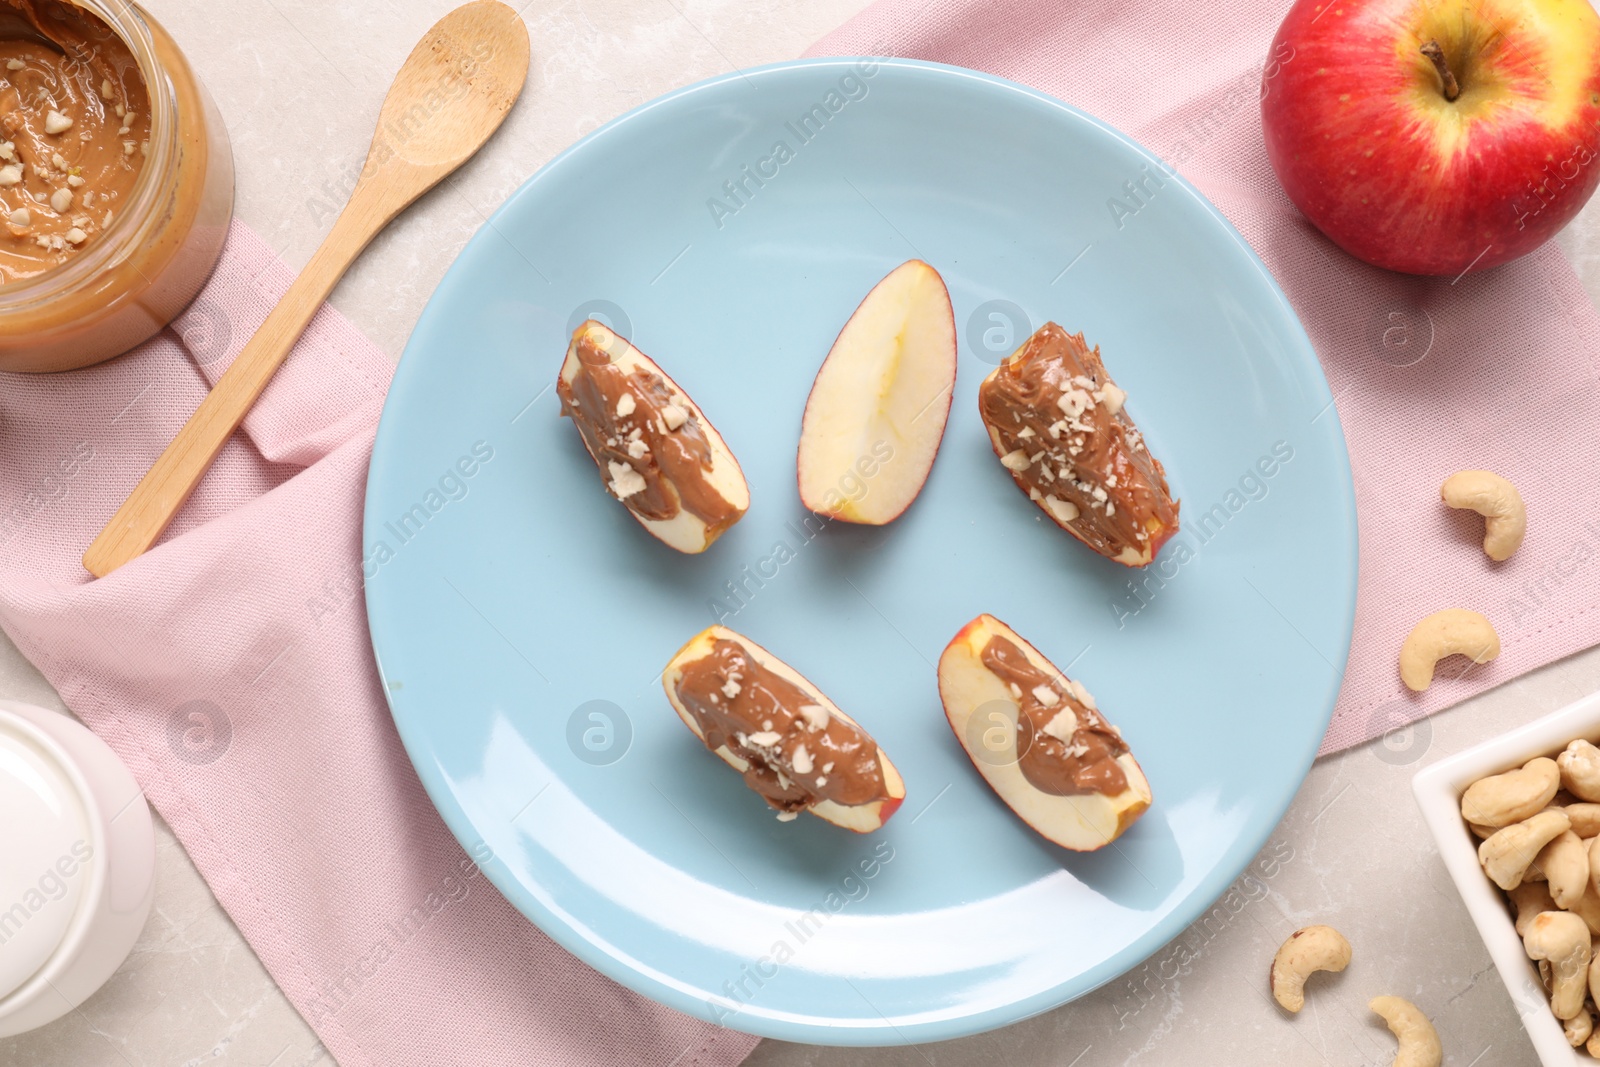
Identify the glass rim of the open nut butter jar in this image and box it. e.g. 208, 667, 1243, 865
0, 0, 179, 315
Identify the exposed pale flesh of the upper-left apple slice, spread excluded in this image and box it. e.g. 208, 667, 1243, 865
560, 318, 750, 553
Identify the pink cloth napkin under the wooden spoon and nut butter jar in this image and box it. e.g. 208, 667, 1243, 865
0, 222, 755, 1067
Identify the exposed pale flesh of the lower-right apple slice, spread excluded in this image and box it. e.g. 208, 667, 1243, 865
939, 614, 1150, 853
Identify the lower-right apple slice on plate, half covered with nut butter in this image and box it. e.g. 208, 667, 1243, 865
939, 614, 1150, 853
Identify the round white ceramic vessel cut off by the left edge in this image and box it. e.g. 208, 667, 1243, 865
0, 701, 155, 1037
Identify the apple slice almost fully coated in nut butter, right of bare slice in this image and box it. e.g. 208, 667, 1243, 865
978, 322, 1178, 566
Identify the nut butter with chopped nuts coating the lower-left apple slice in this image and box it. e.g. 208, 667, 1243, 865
677, 638, 890, 813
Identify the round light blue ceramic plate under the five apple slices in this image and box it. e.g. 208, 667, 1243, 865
365, 59, 1355, 1045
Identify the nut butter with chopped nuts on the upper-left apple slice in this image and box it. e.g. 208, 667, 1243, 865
555, 331, 742, 536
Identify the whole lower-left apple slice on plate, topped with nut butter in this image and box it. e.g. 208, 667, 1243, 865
661, 625, 906, 833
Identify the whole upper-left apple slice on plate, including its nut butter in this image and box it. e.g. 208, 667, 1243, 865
555, 320, 750, 553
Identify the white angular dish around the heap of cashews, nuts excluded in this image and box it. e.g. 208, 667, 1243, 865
1411, 693, 1600, 1067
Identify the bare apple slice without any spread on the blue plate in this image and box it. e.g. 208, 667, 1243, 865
797, 259, 955, 526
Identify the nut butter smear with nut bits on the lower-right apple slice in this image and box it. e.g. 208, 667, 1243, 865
979, 635, 1128, 797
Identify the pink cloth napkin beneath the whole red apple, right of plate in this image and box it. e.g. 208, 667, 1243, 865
808, 0, 1600, 761
